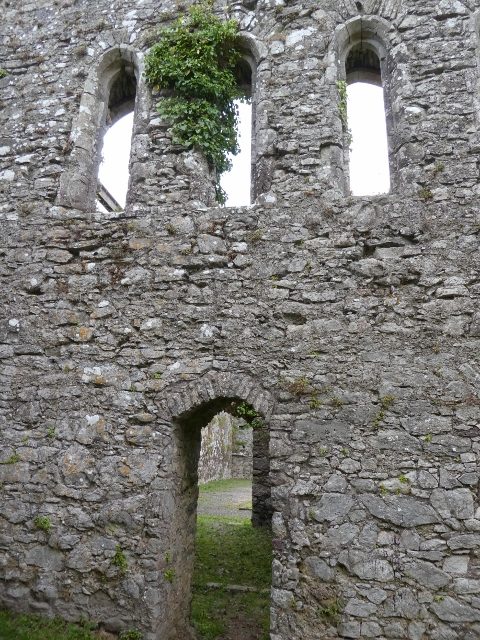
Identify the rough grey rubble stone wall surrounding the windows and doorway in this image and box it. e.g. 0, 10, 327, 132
0, 0, 480, 640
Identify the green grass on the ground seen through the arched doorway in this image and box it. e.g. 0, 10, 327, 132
192, 516, 272, 640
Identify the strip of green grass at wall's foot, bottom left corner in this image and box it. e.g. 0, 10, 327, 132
0, 611, 98, 640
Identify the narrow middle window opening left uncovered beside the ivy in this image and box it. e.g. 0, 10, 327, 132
220, 59, 254, 207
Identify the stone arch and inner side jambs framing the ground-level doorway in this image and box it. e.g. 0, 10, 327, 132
158, 373, 273, 640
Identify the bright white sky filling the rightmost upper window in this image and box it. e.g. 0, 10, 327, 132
347, 82, 390, 196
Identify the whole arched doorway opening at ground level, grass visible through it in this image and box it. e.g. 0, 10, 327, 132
175, 398, 271, 640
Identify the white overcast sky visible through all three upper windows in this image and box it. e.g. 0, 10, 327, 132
98, 83, 390, 206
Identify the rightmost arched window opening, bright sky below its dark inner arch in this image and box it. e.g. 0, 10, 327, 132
345, 42, 390, 196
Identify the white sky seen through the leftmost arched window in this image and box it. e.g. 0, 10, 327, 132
98, 112, 133, 207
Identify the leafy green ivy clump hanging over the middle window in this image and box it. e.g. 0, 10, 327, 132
145, 0, 245, 203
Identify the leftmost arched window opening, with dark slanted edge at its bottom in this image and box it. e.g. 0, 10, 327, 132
97, 63, 137, 211
